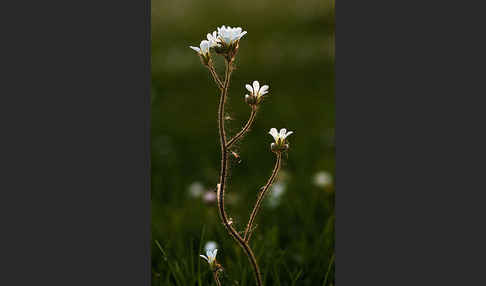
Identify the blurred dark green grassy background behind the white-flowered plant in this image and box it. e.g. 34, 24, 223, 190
151, 0, 335, 285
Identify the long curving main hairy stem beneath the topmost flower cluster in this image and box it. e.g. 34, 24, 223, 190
217, 61, 263, 286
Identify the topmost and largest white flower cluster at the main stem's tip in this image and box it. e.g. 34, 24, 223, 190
190, 25, 247, 62
